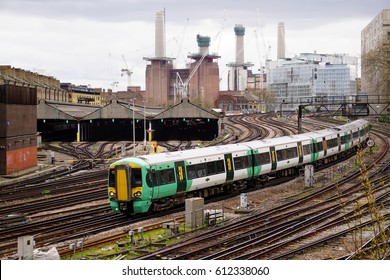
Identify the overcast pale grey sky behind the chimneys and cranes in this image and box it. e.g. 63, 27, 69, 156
0, 0, 390, 90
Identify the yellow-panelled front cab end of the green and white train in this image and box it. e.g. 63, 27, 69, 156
108, 164, 142, 214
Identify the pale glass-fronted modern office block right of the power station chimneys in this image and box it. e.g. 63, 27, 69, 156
268, 53, 357, 110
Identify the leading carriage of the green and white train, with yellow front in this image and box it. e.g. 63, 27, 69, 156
109, 144, 252, 213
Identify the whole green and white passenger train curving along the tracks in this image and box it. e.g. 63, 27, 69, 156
108, 120, 370, 215
